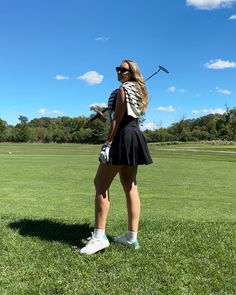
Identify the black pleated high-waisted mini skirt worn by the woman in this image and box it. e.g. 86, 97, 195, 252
108, 116, 152, 166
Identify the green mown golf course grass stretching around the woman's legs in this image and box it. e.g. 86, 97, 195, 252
0, 144, 236, 295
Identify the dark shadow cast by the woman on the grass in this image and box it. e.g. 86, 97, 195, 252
9, 219, 93, 247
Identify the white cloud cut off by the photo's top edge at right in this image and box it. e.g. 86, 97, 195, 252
186, 0, 236, 10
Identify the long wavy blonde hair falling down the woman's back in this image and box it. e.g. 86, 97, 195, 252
123, 59, 148, 112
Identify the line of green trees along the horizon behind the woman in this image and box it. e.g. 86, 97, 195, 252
0, 108, 236, 144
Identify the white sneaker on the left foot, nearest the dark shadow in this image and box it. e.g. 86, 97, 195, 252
80, 233, 110, 255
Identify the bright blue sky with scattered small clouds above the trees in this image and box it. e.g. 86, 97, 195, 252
0, 0, 236, 129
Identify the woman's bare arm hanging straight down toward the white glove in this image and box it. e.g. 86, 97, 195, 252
106, 87, 126, 144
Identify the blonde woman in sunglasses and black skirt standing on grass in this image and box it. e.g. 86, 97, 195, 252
80, 60, 152, 255
